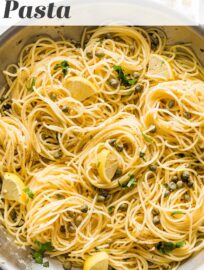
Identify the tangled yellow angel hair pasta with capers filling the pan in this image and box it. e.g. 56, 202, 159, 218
0, 26, 204, 270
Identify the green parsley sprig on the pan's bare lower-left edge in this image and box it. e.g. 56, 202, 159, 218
33, 241, 54, 267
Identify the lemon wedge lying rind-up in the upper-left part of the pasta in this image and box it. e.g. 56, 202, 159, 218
64, 77, 97, 101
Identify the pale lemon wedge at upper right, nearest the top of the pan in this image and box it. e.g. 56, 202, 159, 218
146, 54, 173, 80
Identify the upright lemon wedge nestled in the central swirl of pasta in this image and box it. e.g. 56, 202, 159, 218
98, 149, 119, 183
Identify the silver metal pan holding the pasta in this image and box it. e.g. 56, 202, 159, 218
0, 26, 204, 270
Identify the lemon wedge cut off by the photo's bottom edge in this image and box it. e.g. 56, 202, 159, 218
83, 252, 108, 270
